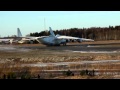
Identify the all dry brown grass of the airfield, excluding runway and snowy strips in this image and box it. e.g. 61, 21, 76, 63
0, 40, 120, 79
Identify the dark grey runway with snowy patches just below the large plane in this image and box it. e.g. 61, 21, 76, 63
0, 44, 120, 53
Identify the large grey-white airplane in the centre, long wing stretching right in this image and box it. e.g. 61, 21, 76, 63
37, 27, 94, 46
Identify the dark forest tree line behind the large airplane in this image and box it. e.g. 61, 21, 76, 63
30, 25, 120, 40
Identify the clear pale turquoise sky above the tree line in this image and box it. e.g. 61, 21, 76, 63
0, 11, 120, 37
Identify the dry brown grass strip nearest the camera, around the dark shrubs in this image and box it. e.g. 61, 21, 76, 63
0, 62, 120, 79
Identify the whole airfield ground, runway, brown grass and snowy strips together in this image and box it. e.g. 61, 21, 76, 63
0, 40, 120, 79
